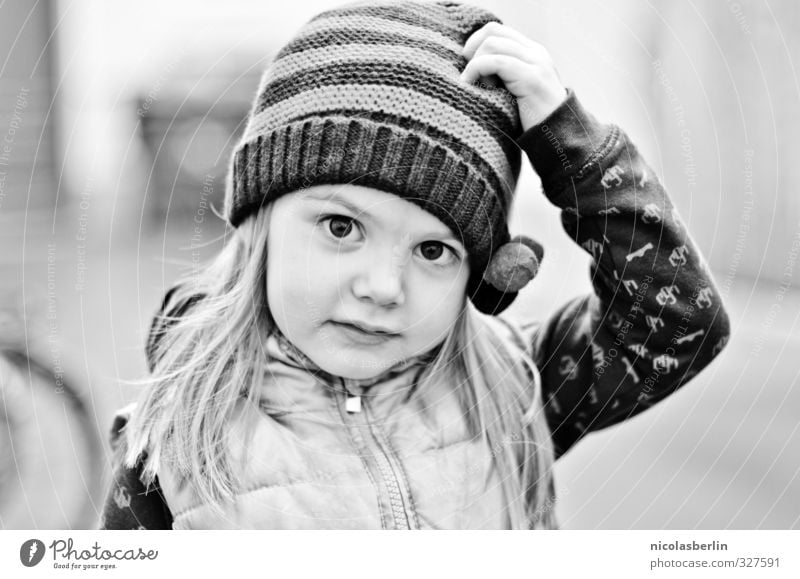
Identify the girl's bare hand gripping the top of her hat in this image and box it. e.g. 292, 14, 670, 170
461, 22, 567, 131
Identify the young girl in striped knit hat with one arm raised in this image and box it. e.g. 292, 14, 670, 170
103, 1, 729, 529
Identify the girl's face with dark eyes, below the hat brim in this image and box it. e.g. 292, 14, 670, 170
267, 185, 469, 379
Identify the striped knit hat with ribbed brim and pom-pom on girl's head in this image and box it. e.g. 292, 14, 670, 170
225, 1, 543, 314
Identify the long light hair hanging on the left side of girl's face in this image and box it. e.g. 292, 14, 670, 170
125, 205, 273, 503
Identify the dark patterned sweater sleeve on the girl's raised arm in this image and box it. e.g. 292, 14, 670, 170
504, 91, 730, 457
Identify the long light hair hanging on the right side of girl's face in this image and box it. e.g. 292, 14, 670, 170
418, 301, 557, 529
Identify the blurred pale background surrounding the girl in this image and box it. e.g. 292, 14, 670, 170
0, 0, 800, 529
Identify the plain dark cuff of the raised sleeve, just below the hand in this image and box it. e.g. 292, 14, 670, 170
517, 89, 614, 196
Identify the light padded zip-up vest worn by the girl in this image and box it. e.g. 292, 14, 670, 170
158, 322, 532, 529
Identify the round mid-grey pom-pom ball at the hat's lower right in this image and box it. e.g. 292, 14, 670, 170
483, 235, 544, 293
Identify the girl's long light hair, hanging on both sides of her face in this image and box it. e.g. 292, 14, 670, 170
124, 204, 555, 529
